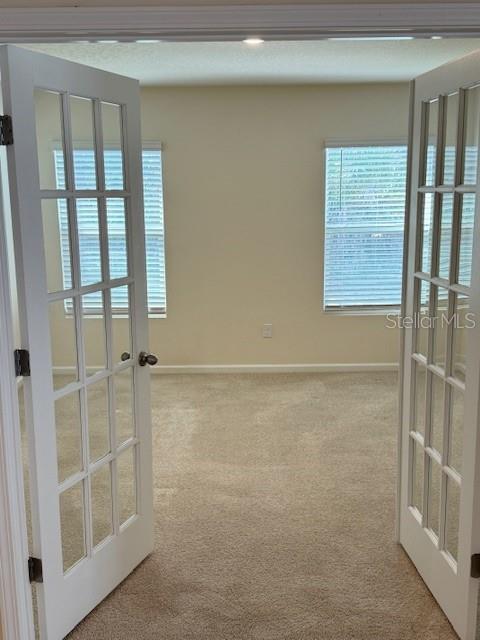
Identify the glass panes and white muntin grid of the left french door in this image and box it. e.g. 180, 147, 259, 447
37, 89, 139, 575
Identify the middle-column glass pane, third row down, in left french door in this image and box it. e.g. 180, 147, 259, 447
82, 291, 107, 376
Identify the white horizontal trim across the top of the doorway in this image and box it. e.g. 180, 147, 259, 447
0, 2, 480, 42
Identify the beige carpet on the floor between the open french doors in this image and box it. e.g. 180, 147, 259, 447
64, 373, 456, 640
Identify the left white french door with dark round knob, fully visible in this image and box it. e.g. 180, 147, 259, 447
0, 46, 153, 640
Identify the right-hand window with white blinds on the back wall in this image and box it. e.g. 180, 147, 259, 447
324, 145, 407, 310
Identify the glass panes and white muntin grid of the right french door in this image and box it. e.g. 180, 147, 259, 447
408, 86, 480, 572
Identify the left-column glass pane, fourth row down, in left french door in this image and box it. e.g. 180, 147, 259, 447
55, 391, 83, 483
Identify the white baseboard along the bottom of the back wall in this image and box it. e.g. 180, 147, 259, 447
53, 362, 398, 376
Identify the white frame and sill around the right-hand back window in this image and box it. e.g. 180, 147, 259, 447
322, 138, 408, 316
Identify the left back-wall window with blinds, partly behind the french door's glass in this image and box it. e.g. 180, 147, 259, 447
54, 149, 167, 315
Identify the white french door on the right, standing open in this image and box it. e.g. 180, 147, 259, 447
400, 52, 480, 640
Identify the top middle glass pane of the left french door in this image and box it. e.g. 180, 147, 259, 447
70, 96, 97, 189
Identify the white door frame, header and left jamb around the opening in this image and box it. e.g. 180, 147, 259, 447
0, 2, 480, 640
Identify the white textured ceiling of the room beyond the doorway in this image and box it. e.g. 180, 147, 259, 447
20, 39, 480, 85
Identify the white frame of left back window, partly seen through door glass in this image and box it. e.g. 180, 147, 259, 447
50, 140, 167, 320
